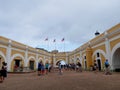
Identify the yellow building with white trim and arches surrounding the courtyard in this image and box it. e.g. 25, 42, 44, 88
0, 24, 120, 72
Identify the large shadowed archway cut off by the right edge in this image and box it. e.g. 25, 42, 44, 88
112, 47, 120, 72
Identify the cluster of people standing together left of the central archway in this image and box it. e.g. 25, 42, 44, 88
38, 61, 52, 76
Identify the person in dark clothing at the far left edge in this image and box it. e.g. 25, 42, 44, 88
0, 62, 7, 83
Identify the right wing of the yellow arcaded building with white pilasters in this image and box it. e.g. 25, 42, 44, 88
69, 24, 120, 70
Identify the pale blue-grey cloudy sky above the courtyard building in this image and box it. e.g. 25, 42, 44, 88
0, 0, 120, 52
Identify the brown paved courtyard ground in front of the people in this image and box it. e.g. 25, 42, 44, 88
0, 71, 120, 90
